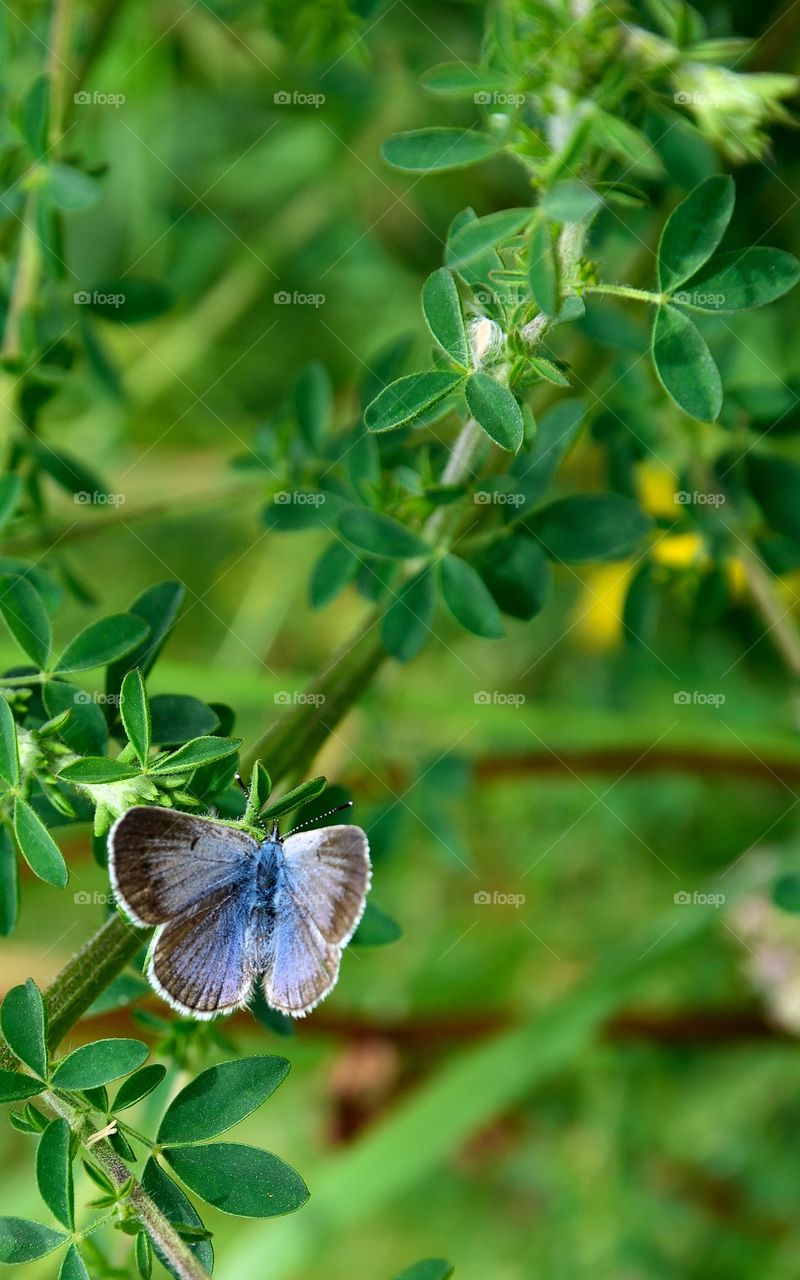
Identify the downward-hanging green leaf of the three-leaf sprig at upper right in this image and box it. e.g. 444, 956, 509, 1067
653, 307, 722, 422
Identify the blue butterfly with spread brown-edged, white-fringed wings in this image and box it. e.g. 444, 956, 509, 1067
109, 805, 371, 1019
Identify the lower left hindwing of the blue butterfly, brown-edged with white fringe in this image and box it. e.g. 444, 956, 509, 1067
147, 882, 253, 1019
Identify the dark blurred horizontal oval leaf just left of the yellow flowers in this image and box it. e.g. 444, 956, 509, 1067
527, 493, 653, 564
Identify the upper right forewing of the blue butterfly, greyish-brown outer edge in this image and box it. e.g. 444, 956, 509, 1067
277, 826, 371, 947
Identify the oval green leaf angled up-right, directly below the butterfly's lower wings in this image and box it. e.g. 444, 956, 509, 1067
156, 1057, 289, 1146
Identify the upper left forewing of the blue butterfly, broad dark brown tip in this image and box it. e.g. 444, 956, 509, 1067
109, 805, 259, 924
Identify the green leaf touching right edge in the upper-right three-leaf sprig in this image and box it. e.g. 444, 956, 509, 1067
675, 244, 800, 311
